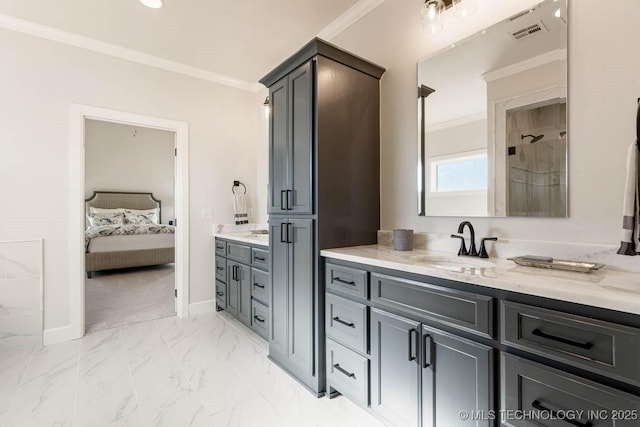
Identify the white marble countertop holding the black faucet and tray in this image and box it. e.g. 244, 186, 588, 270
320, 245, 640, 315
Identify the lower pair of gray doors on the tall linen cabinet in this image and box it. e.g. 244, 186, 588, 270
269, 218, 315, 379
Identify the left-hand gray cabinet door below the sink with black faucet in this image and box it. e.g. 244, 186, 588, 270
371, 308, 422, 427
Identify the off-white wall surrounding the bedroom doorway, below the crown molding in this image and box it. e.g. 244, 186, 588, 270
0, 30, 264, 329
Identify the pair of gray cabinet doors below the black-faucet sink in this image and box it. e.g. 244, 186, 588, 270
371, 308, 493, 427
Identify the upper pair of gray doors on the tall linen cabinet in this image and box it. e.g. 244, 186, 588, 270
269, 61, 313, 215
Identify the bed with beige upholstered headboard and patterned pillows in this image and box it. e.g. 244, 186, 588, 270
85, 191, 175, 278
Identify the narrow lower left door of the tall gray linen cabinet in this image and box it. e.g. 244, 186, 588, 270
268, 221, 289, 363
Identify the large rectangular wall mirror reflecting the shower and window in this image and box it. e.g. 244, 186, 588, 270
418, 0, 569, 217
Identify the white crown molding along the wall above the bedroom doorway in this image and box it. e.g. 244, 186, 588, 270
0, 14, 262, 92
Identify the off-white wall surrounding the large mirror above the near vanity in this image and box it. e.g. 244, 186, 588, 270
332, 0, 640, 245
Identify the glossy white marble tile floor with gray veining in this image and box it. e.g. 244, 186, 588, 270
0, 312, 382, 427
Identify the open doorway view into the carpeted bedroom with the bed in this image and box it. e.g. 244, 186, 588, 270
84, 119, 176, 333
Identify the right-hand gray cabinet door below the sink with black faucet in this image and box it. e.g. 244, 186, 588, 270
420, 325, 493, 427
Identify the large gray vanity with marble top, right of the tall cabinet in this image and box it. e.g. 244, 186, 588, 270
322, 245, 640, 427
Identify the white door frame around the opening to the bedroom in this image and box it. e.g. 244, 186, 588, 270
68, 103, 189, 339
